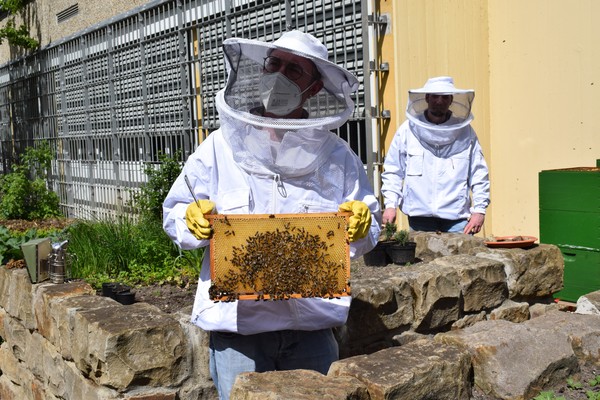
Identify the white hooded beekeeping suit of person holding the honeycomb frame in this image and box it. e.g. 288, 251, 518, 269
164, 31, 381, 335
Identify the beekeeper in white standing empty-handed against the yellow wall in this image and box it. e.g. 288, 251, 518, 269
381, 76, 490, 234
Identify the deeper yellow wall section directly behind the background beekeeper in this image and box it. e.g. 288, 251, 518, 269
379, 0, 495, 235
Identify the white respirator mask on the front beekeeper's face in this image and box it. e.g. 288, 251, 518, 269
258, 72, 315, 117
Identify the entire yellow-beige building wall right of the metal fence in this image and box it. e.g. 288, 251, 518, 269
378, 0, 600, 237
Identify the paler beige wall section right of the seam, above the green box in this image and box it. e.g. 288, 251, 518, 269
489, 0, 600, 237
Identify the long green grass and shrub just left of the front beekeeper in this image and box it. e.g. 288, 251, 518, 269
68, 153, 204, 287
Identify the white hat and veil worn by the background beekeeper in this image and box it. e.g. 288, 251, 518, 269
406, 76, 475, 157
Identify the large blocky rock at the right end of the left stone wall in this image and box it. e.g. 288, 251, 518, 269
72, 303, 189, 390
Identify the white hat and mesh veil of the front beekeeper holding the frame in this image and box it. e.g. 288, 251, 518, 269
216, 30, 358, 177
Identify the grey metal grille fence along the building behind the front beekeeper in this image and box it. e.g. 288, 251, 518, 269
0, 0, 373, 219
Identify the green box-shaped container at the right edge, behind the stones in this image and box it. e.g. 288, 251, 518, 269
539, 160, 600, 302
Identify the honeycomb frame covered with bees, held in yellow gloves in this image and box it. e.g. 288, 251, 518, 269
208, 212, 350, 301
